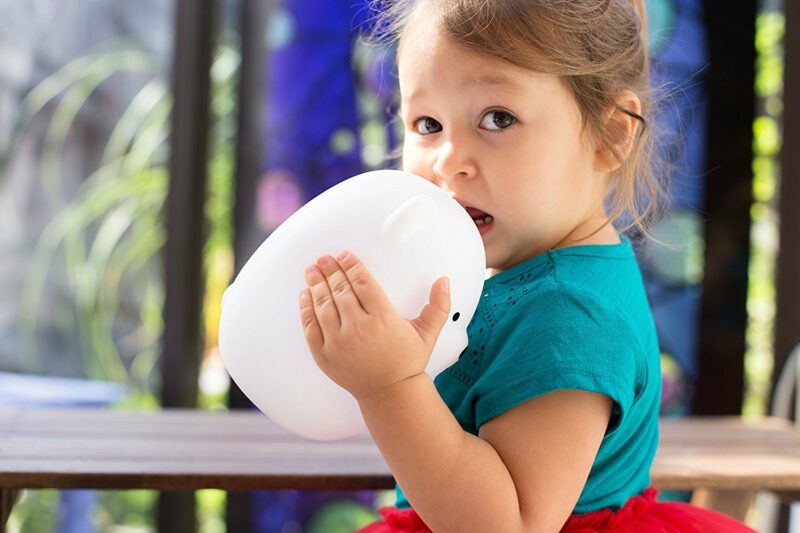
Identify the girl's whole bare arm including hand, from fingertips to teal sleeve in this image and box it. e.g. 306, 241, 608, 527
300, 254, 611, 533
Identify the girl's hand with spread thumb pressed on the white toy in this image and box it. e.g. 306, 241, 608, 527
300, 252, 450, 399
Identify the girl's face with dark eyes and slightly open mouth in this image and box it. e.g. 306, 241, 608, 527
398, 17, 616, 270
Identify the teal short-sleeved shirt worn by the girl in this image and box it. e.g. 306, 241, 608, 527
395, 238, 661, 513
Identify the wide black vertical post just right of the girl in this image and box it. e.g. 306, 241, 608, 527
693, 0, 756, 414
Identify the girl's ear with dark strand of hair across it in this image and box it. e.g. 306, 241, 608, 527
594, 89, 644, 173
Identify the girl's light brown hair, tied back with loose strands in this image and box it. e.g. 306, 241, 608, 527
373, 0, 668, 236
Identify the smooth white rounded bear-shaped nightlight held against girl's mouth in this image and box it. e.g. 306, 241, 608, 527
219, 170, 486, 440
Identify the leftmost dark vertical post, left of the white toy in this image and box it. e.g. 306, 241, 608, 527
158, 0, 216, 532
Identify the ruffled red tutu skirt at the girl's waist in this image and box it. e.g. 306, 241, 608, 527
356, 488, 756, 533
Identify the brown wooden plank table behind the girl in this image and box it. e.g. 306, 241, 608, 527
0, 408, 800, 525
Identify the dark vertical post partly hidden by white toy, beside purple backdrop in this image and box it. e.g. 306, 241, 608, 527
226, 0, 272, 532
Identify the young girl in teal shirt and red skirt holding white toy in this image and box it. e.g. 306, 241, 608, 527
300, 0, 752, 533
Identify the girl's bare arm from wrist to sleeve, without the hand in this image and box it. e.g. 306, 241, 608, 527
359, 375, 611, 533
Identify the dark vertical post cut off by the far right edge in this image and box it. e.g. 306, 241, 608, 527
772, 0, 800, 406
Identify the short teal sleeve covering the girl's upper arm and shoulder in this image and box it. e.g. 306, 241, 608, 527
475, 281, 644, 435
